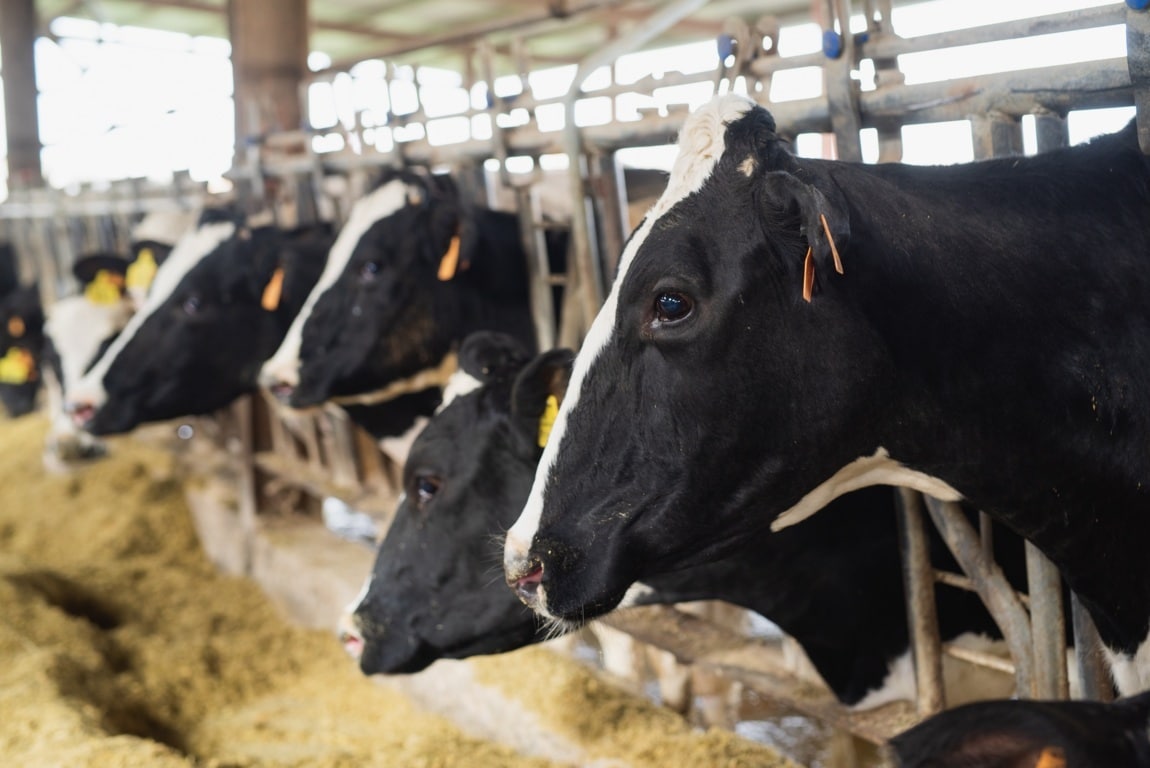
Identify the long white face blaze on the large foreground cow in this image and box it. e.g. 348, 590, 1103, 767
507, 93, 754, 558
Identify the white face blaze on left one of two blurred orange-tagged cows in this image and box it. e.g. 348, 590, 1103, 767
66, 222, 236, 406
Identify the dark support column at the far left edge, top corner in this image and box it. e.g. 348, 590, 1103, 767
0, 0, 44, 190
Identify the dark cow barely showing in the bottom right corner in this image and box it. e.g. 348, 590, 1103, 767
890, 693, 1150, 768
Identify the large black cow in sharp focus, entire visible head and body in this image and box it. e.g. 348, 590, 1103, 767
505, 95, 1150, 693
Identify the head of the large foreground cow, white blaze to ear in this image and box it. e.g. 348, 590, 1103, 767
505, 95, 884, 621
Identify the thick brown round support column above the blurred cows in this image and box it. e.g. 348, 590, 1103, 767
228, 0, 308, 157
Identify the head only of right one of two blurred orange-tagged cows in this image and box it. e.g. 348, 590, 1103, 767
261, 170, 519, 408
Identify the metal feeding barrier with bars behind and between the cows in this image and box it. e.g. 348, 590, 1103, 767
0, 0, 1150, 743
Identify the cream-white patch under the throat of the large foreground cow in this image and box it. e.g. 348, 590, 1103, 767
771, 447, 963, 531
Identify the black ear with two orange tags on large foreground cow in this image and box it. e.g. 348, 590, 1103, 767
762, 171, 851, 301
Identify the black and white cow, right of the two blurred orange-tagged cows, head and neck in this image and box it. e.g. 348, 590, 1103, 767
260, 165, 561, 446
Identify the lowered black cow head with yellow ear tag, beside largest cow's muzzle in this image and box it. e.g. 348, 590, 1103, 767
344, 332, 570, 674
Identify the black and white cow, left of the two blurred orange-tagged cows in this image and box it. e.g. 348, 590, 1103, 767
67, 210, 331, 435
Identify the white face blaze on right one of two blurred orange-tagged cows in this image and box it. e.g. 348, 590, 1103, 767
263, 179, 419, 384
